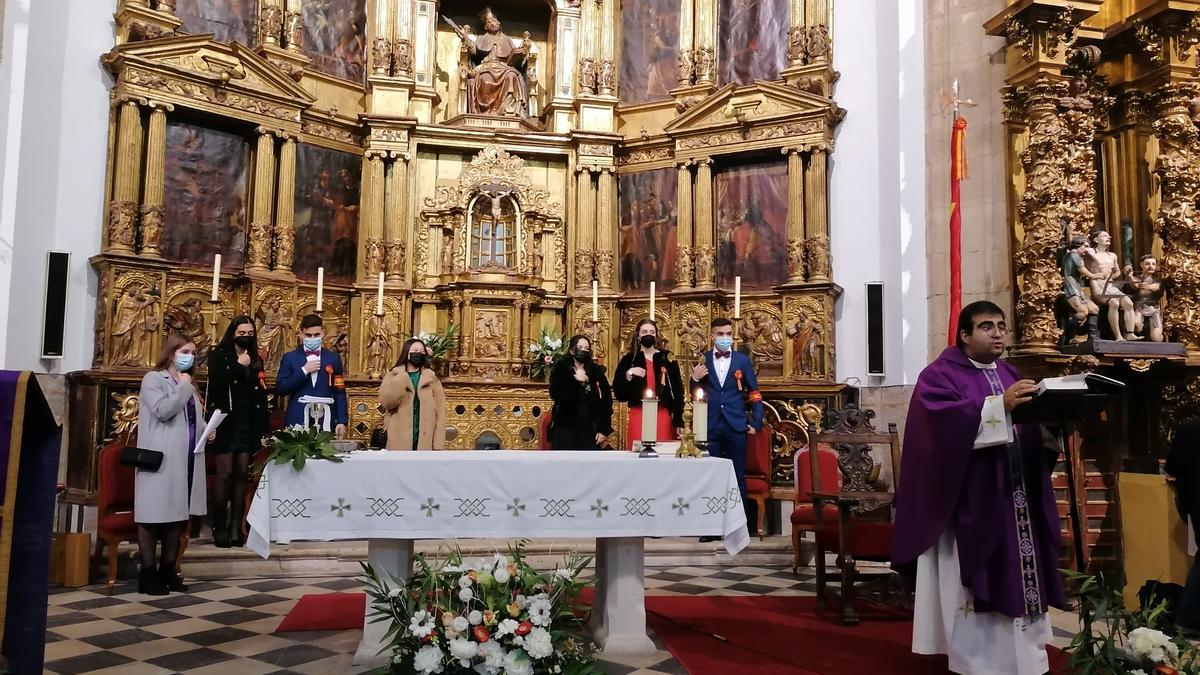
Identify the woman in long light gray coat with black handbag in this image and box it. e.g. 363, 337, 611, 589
133, 333, 212, 596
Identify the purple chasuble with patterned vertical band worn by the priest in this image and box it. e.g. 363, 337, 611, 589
892, 347, 1066, 619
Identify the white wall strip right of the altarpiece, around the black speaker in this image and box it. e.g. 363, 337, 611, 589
829, 0, 929, 386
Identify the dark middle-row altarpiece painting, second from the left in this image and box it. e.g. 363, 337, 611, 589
292, 145, 362, 282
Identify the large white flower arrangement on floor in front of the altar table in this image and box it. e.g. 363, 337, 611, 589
362, 542, 600, 675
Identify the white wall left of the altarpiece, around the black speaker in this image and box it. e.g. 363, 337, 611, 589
0, 0, 115, 372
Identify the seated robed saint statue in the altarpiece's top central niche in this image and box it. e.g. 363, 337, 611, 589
446, 10, 529, 119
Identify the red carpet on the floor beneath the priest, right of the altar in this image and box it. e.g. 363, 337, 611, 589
646, 596, 1067, 675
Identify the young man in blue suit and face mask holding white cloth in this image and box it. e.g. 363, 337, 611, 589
275, 313, 347, 438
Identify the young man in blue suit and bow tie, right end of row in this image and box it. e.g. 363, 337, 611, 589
691, 318, 762, 540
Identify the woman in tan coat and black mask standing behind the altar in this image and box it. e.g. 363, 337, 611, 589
379, 338, 446, 450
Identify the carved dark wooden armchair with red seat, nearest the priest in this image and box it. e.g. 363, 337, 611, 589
809, 404, 911, 626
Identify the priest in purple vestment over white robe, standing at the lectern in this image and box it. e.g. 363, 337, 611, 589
893, 301, 1066, 675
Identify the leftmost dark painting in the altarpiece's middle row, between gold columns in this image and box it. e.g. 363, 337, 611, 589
162, 121, 250, 269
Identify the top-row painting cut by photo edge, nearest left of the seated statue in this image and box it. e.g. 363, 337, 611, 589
301, 0, 367, 82
